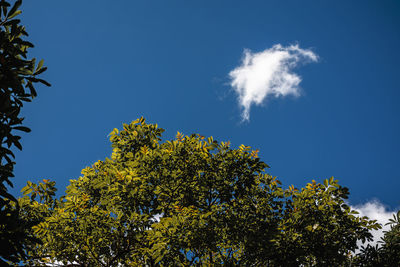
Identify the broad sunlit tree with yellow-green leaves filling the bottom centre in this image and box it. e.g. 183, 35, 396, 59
19, 118, 382, 266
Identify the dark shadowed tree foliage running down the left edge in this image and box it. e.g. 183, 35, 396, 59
0, 0, 50, 264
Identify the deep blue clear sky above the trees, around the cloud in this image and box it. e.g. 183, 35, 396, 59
11, 0, 400, 208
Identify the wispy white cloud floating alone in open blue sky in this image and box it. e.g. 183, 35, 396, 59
229, 44, 318, 121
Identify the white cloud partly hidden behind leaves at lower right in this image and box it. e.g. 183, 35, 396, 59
351, 200, 395, 246
